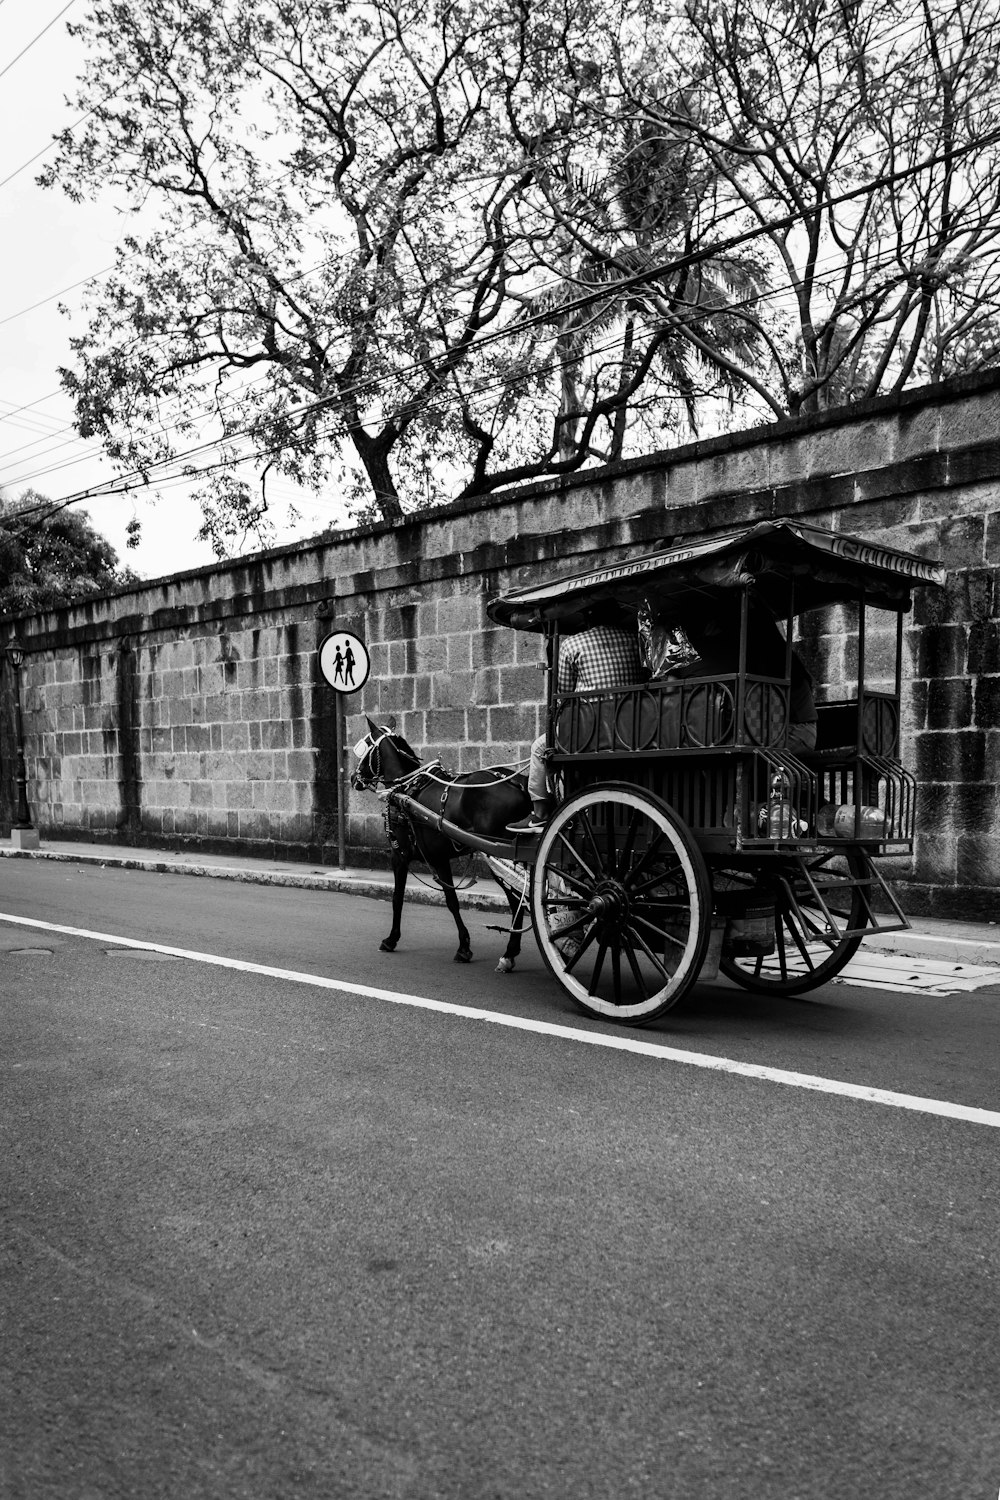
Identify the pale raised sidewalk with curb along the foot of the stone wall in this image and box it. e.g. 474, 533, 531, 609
0, 839, 1000, 968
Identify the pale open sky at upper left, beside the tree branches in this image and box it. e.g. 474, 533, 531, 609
0, 0, 337, 578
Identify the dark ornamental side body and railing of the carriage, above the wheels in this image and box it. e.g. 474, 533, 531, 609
550, 675, 915, 854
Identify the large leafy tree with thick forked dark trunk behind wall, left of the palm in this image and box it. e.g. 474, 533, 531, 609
42, 0, 761, 551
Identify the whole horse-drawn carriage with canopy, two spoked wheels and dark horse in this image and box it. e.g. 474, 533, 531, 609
355, 521, 945, 1025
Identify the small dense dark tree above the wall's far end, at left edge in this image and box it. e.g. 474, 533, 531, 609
0, 491, 136, 615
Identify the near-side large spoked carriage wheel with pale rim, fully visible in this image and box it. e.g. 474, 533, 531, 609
531, 782, 712, 1026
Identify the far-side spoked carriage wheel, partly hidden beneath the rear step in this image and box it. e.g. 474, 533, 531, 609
714, 849, 868, 995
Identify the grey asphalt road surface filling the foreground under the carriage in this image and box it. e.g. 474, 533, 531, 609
0, 861, 1000, 1500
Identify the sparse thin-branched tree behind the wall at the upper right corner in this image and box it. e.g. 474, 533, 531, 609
619, 0, 1000, 416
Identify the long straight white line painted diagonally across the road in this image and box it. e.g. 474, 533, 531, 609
0, 912, 1000, 1128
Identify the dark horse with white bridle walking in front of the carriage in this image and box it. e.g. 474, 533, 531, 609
351, 714, 531, 974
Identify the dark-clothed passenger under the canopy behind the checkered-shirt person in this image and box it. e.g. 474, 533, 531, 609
673, 599, 817, 755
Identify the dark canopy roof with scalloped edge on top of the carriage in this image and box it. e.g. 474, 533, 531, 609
487, 521, 946, 630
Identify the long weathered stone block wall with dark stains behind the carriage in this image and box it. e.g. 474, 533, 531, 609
0, 375, 1000, 917
